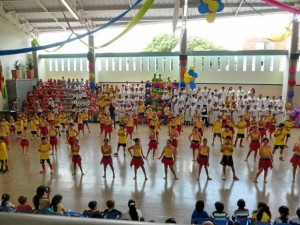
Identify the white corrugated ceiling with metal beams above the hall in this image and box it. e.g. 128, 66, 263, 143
0, 0, 300, 36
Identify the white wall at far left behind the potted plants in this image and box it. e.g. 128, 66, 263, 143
0, 16, 30, 111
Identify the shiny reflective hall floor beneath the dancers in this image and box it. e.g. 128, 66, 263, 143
0, 124, 300, 223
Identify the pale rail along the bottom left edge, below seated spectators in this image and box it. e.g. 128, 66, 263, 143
0, 212, 159, 225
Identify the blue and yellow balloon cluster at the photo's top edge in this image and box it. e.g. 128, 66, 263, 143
198, 0, 224, 23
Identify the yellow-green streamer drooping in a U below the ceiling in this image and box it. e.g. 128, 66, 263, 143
63, 0, 154, 49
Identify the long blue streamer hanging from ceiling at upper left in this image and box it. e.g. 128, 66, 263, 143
0, 0, 142, 56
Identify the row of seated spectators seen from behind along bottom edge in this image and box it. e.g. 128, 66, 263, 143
0, 185, 300, 225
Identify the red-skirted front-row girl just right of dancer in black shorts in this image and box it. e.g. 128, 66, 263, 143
254, 138, 273, 183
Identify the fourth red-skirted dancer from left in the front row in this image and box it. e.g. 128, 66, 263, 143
158, 139, 178, 180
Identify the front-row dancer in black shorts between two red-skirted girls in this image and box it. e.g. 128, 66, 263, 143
221, 136, 239, 180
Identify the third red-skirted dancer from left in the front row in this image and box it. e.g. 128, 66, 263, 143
128, 138, 148, 180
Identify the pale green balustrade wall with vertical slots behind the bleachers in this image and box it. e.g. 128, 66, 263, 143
39, 50, 288, 84
